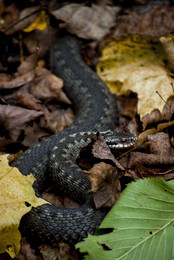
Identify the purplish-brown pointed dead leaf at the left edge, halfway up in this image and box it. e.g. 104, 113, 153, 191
0, 105, 43, 141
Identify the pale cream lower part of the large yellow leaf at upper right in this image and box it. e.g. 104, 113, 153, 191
114, 64, 174, 118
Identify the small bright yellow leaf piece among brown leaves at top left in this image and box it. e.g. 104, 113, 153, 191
23, 10, 48, 32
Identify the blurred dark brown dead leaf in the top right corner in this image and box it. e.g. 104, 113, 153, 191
112, 1, 174, 37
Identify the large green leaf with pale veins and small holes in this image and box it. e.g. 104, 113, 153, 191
76, 179, 174, 260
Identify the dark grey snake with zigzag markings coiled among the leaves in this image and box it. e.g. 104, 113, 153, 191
12, 35, 136, 244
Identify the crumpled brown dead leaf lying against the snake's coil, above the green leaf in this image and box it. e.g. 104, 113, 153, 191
85, 162, 121, 209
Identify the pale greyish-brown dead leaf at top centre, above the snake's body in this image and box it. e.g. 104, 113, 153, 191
52, 3, 120, 40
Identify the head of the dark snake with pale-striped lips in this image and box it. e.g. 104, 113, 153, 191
101, 130, 137, 149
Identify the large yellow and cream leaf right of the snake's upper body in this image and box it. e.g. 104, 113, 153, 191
97, 35, 174, 119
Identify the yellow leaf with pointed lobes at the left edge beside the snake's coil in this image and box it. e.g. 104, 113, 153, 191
0, 155, 47, 258
